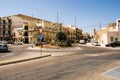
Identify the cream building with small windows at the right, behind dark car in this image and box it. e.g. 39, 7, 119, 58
95, 19, 120, 46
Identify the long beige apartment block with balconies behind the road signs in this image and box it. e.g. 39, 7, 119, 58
14, 15, 60, 43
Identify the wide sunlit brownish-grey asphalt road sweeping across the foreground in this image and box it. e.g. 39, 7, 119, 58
0, 46, 120, 80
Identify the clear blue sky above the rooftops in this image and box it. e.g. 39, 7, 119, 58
0, 0, 120, 34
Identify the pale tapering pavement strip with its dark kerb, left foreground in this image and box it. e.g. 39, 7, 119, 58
0, 52, 51, 66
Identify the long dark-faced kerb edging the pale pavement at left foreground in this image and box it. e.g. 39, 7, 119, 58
0, 54, 51, 66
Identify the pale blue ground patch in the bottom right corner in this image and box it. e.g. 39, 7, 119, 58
105, 67, 120, 79
